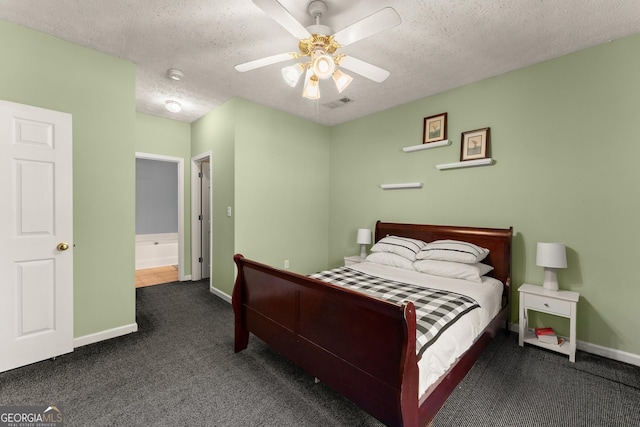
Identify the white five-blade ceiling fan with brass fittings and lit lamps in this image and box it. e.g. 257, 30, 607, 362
235, 0, 401, 99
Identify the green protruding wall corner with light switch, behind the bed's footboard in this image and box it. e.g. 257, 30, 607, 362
192, 98, 330, 295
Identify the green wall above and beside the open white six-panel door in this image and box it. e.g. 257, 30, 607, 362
0, 21, 136, 338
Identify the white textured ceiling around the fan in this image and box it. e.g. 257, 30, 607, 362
0, 0, 640, 125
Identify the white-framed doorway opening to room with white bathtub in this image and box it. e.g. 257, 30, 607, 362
136, 153, 188, 287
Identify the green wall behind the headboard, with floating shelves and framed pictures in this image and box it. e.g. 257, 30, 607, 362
329, 35, 640, 355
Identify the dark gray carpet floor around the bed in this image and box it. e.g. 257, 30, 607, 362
0, 282, 640, 427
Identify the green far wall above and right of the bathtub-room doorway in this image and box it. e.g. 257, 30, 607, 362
135, 113, 191, 275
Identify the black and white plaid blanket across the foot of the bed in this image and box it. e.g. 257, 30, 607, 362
310, 267, 480, 359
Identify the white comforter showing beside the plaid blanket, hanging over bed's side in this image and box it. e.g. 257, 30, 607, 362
349, 262, 502, 396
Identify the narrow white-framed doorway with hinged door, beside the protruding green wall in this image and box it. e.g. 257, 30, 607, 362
191, 152, 211, 280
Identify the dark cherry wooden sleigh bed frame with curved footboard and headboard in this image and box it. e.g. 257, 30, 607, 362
232, 221, 512, 426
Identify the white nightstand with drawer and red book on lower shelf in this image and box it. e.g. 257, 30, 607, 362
518, 284, 580, 362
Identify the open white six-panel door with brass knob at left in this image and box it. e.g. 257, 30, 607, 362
0, 101, 73, 372
